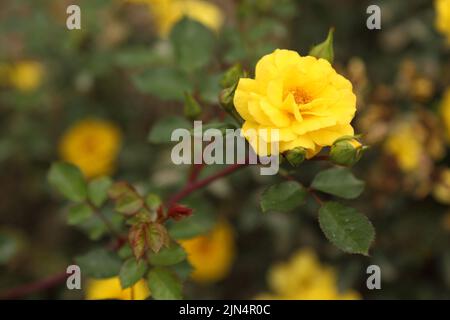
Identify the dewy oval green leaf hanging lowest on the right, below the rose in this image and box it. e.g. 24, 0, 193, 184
319, 202, 375, 255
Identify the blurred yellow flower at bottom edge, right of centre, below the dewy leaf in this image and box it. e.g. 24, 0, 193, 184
257, 249, 360, 300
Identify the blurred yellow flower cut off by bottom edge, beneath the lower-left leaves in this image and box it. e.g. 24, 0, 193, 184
86, 277, 150, 300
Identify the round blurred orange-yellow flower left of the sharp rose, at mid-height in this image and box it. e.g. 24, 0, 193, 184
59, 119, 121, 178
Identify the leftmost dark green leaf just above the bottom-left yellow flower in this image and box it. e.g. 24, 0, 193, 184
75, 249, 122, 279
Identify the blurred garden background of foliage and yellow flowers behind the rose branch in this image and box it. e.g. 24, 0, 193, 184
0, 0, 450, 299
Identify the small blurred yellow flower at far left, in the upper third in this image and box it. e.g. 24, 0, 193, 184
9, 61, 44, 92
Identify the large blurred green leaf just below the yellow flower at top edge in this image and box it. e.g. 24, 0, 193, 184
170, 18, 215, 71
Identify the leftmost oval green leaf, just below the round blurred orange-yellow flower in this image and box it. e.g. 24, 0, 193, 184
48, 162, 87, 202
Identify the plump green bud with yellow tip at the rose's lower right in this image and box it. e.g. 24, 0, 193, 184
330, 137, 366, 167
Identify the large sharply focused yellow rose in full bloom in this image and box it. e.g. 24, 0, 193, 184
234, 49, 356, 158
